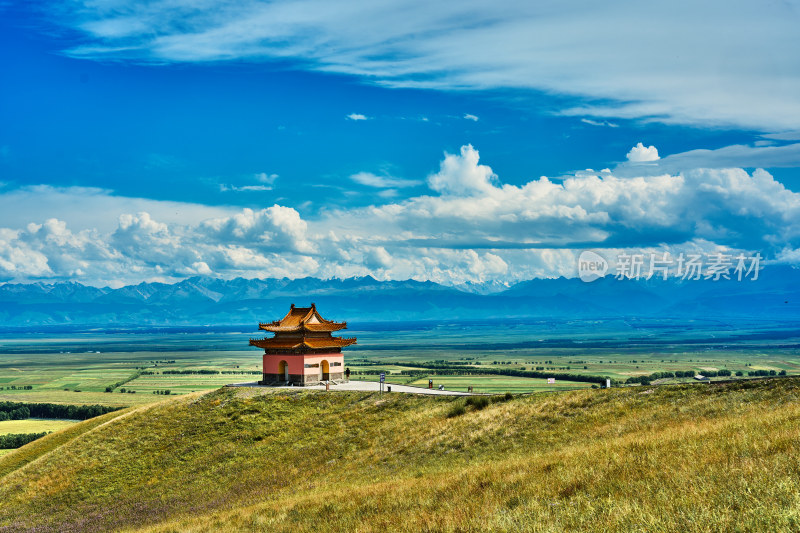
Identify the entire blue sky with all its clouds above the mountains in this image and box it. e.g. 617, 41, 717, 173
0, 0, 800, 285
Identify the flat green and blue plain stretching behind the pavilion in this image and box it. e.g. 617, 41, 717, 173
0, 320, 800, 406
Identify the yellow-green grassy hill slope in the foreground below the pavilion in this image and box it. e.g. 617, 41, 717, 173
0, 379, 800, 532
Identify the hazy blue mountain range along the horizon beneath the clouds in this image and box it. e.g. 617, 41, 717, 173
0, 266, 800, 327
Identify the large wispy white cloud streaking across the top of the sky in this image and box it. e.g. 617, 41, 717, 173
52, 0, 800, 131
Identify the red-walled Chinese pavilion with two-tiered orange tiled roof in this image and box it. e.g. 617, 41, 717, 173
250, 304, 356, 385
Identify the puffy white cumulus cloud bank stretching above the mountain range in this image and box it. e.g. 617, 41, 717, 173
0, 145, 800, 286
